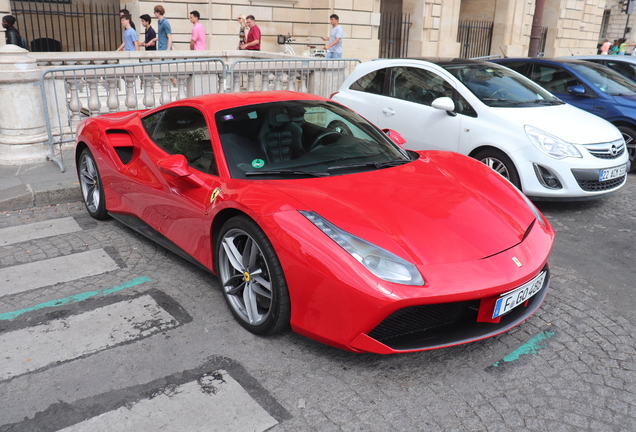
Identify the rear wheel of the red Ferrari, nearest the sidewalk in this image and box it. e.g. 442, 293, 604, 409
77, 148, 108, 220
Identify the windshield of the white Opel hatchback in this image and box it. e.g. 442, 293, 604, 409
444, 64, 563, 107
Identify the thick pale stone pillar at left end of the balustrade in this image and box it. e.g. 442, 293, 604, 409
0, 45, 50, 164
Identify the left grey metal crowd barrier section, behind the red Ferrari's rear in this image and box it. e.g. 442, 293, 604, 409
40, 58, 226, 172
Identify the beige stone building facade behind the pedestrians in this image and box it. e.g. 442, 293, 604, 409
0, 0, 636, 61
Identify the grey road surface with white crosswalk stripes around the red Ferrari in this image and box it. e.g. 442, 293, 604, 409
0, 175, 636, 432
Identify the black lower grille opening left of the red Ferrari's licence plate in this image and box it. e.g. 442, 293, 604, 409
369, 300, 479, 342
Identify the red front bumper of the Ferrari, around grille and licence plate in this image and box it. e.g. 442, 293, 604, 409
261, 212, 554, 354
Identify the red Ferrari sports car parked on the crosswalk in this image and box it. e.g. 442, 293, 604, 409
76, 92, 554, 353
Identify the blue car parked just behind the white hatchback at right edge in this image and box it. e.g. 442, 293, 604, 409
490, 58, 636, 172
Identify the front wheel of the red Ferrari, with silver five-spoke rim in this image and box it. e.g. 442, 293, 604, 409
215, 216, 290, 335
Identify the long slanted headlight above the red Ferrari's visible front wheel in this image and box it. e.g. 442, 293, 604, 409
300, 211, 424, 286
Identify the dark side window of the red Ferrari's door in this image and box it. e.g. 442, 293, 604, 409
143, 107, 219, 175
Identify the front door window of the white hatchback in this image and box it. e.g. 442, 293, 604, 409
389, 67, 453, 106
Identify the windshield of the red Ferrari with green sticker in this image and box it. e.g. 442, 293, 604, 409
215, 100, 411, 179
